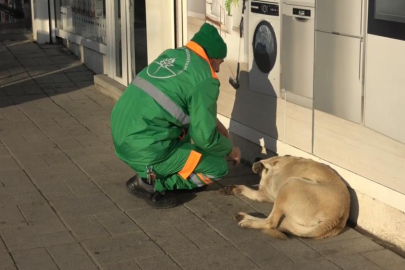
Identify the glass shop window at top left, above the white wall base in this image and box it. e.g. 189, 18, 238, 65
55, 0, 107, 44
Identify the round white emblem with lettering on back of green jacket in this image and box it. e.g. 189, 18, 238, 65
146, 48, 190, 79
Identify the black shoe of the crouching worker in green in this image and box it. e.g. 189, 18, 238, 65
126, 175, 180, 209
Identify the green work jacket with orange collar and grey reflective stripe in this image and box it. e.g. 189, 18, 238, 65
111, 41, 232, 168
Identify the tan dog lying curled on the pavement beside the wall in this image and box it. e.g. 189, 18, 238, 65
224, 156, 350, 239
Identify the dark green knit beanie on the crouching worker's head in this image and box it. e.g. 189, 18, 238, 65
191, 23, 227, 59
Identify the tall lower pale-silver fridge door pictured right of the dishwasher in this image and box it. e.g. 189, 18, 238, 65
314, 31, 363, 123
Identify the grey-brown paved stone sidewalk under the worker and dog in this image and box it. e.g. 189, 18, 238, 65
0, 38, 405, 270
